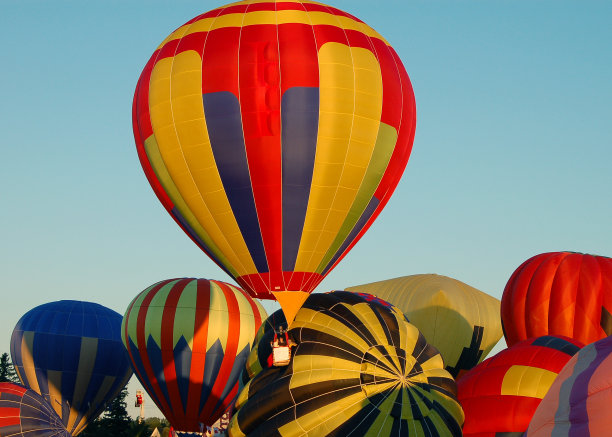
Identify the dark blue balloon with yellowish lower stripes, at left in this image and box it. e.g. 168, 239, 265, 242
11, 300, 132, 436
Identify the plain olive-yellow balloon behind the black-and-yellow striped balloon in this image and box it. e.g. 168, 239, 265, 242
347, 274, 502, 377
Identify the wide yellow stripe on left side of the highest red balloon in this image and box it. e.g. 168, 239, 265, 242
149, 46, 253, 278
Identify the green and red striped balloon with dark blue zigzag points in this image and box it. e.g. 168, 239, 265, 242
121, 278, 267, 432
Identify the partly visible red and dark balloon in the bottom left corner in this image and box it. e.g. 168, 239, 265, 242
0, 382, 70, 437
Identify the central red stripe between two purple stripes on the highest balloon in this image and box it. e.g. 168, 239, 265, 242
236, 23, 283, 282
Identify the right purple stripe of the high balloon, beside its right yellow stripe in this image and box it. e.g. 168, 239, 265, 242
281, 87, 319, 271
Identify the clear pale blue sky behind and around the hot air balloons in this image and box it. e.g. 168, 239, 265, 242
0, 0, 612, 418
